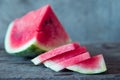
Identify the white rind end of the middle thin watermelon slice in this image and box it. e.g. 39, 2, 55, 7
43, 60, 64, 72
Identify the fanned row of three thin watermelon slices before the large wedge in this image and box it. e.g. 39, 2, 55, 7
31, 42, 106, 74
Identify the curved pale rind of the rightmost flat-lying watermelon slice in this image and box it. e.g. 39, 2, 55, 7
66, 56, 107, 74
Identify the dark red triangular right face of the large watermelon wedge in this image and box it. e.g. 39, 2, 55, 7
37, 7, 69, 47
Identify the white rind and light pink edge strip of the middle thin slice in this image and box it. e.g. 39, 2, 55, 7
44, 52, 90, 72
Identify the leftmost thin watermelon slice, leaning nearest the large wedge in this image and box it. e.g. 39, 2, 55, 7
31, 42, 80, 65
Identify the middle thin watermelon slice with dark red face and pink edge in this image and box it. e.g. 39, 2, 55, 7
44, 51, 90, 72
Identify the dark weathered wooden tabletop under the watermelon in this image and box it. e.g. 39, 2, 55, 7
0, 43, 120, 80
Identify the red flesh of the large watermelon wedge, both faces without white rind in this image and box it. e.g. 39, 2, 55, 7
10, 5, 70, 51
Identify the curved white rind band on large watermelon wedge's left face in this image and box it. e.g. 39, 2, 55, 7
5, 22, 36, 54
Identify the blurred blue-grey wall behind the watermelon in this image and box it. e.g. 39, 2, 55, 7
0, 0, 120, 48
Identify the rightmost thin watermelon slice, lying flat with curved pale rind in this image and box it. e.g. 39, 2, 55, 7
67, 54, 107, 74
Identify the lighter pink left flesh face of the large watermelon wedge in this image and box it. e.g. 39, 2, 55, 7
10, 6, 47, 48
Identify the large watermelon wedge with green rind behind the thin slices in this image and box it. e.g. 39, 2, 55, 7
5, 5, 71, 56
